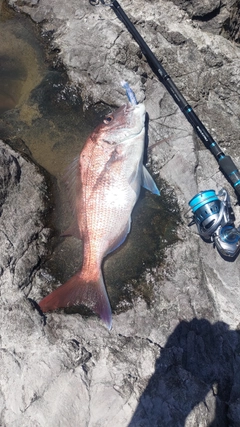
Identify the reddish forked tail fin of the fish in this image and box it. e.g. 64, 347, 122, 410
39, 272, 112, 330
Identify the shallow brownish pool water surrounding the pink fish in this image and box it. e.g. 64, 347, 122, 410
0, 3, 179, 312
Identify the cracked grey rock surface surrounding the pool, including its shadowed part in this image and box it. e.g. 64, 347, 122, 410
0, 0, 240, 427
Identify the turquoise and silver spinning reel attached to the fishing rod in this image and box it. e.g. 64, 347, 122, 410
189, 189, 240, 257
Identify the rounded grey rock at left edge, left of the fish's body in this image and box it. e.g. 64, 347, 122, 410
0, 141, 50, 293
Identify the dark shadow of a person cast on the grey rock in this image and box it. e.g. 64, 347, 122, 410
129, 319, 240, 427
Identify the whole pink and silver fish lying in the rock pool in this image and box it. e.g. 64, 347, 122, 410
39, 103, 160, 330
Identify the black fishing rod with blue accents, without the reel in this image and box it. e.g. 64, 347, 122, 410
89, 0, 240, 196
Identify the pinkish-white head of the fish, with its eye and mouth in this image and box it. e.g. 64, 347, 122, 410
91, 103, 146, 145
